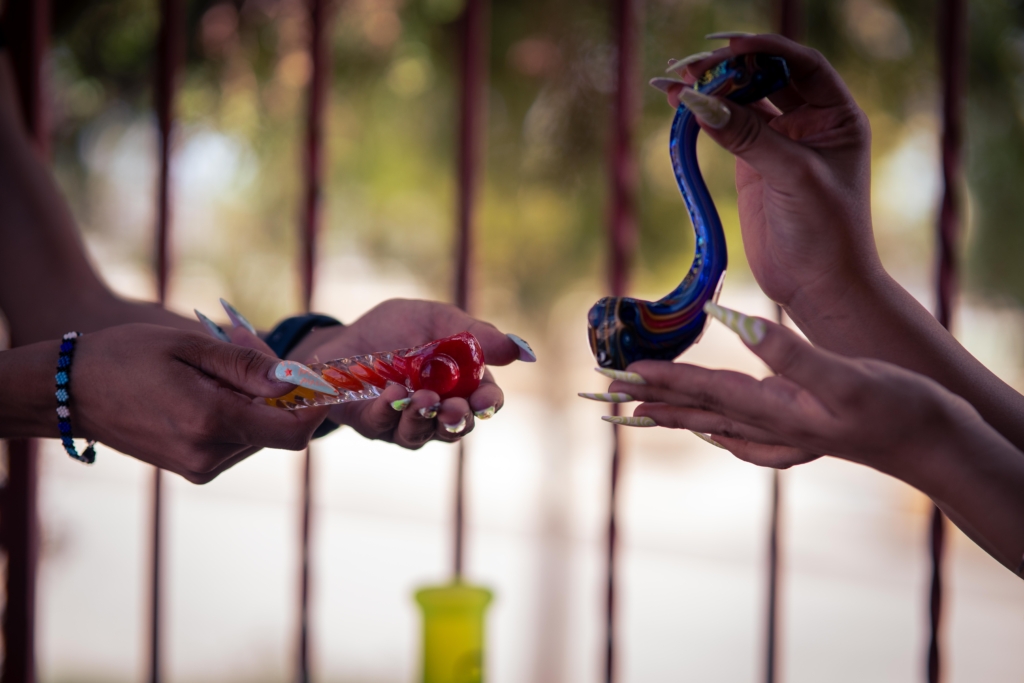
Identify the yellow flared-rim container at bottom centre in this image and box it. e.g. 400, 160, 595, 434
416, 583, 494, 683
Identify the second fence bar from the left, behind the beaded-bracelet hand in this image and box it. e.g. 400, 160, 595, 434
148, 0, 184, 683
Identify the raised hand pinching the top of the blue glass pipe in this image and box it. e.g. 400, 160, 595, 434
669, 36, 882, 310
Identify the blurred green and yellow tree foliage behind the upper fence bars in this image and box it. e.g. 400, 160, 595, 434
46, 0, 1024, 331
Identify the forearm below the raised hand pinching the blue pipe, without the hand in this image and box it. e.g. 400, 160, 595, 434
786, 268, 1024, 451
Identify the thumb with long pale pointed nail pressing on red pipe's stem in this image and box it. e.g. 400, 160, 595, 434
178, 339, 338, 398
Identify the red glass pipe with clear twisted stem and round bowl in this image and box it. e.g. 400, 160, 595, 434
266, 332, 483, 410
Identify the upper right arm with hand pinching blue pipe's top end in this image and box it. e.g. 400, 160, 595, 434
670, 36, 1024, 450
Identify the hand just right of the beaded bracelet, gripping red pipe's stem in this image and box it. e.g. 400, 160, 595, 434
74, 325, 327, 483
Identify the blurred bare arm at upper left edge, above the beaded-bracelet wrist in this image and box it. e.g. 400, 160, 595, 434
0, 52, 202, 346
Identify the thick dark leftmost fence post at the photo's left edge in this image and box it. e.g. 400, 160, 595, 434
0, 0, 50, 683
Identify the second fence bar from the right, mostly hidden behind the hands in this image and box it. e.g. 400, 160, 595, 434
764, 5, 804, 683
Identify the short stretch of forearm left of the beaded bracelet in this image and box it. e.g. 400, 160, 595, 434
0, 341, 60, 438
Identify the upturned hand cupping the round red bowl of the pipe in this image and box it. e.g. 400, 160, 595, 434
284, 299, 536, 450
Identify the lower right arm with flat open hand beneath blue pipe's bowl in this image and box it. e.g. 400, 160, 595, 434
609, 306, 1024, 572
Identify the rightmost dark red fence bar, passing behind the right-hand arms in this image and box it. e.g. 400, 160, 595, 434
927, 0, 968, 683
